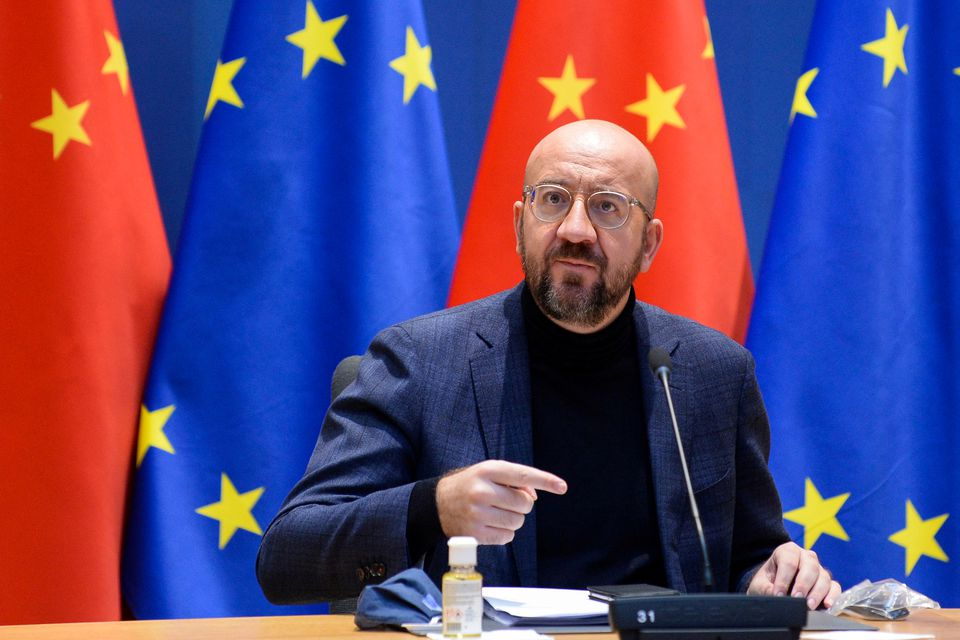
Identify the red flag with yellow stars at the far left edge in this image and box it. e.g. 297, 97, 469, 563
0, 0, 170, 624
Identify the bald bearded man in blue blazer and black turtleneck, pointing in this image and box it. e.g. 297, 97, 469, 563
257, 121, 840, 608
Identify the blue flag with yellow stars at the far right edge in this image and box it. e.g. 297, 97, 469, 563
748, 0, 960, 607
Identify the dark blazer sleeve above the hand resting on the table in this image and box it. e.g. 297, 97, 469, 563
730, 353, 790, 591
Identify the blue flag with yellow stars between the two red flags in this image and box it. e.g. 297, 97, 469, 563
123, 0, 459, 618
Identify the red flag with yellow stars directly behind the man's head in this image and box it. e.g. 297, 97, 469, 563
450, 0, 753, 342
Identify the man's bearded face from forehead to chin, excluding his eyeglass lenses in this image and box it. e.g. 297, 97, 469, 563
514, 126, 660, 331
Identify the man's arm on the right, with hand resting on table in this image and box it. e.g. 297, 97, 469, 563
731, 354, 840, 609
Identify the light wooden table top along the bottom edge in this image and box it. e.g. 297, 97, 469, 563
0, 609, 960, 640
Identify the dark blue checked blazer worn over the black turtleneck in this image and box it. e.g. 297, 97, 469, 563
257, 285, 789, 603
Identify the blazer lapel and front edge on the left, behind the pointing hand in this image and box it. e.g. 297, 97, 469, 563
470, 287, 537, 586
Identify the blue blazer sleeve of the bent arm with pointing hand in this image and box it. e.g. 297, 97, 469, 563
257, 327, 430, 604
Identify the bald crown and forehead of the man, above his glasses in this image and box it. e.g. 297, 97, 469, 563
524, 120, 660, 215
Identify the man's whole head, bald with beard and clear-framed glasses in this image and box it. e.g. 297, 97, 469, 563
513, 120, 663, 333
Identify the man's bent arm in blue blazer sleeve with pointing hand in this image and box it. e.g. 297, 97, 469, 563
257, 320, 566, 604
